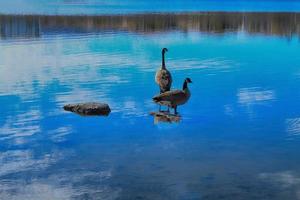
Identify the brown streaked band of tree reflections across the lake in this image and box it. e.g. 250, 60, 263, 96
0, 12, 300, 38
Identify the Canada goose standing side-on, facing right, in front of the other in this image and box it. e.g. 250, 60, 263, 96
153, 78, 192, 115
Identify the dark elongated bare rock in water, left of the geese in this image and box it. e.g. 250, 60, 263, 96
64, 102, 110, 116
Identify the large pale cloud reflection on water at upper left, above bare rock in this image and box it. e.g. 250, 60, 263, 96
0, 36, 129, 99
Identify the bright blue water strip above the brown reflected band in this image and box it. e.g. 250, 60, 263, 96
0, 0, 300, 15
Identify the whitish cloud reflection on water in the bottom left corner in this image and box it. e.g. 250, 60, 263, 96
0, 170, 121, 200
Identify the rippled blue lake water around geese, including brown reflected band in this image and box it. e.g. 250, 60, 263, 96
0, 10, 300, 200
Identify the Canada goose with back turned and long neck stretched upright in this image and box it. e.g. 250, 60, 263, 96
155, 48, 172, 93
